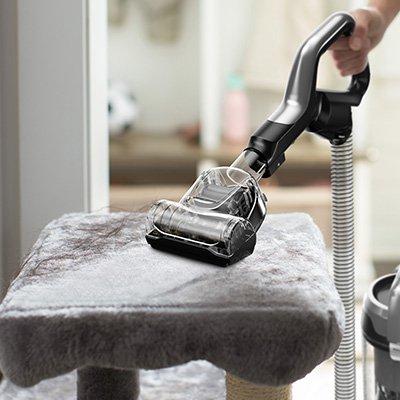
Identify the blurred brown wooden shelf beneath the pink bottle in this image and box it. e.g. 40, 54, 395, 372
110, 132, 330, 184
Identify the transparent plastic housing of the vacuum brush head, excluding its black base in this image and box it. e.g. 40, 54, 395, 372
148, 167, 262, 255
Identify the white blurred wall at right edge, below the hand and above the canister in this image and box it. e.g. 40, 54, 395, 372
366, 18, 400, 261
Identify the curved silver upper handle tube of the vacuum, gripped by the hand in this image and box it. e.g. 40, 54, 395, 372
268, 12, 360, 125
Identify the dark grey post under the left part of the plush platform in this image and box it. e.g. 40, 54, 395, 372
78, 367, 140, 400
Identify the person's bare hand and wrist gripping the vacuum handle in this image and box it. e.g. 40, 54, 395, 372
331, 0, 400, 76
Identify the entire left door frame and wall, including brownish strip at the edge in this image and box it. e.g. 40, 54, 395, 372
0, 0, 109, 289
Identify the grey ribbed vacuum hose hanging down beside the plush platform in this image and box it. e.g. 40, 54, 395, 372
331, 136, 356, 400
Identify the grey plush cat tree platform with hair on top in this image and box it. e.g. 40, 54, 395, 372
0, 213, 344, 394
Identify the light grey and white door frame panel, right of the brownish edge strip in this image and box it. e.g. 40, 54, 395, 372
18, 0, 108, 252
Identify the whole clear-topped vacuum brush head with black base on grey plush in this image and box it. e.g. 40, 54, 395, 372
146, 167, 266, 266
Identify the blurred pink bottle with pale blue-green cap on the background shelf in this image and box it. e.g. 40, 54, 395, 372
223, 74, 250, 144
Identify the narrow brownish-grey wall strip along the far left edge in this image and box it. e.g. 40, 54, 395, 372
0, 0, 21, 297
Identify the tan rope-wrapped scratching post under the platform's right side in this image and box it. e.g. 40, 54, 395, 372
226, 373, 292, 400
